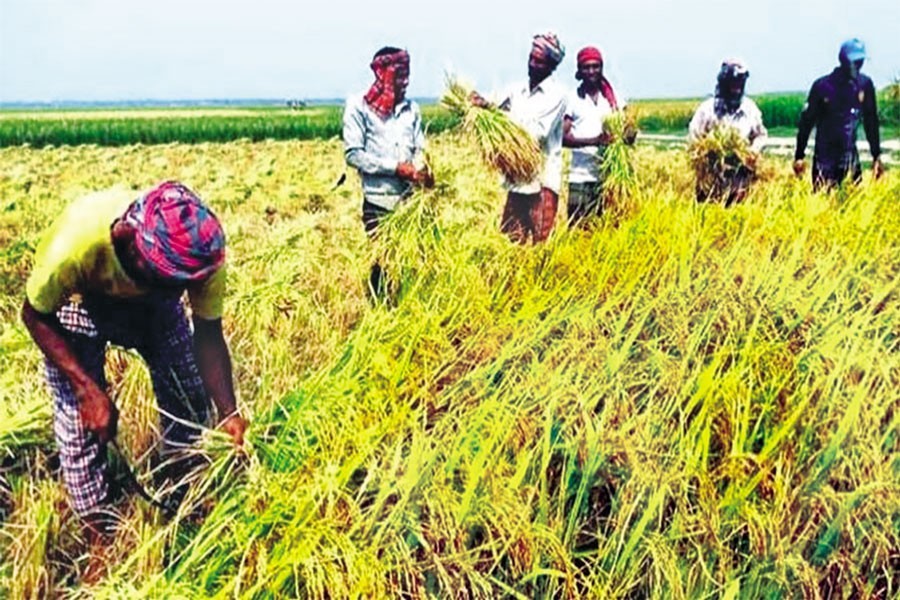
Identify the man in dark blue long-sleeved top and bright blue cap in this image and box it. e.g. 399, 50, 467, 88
794, 38, 884, 190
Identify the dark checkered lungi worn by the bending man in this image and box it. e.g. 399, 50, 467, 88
45, 295, 209, 516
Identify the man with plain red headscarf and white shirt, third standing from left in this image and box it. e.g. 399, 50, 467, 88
563, 46, 634, 224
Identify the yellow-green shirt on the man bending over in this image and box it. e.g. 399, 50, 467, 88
25, 189, 227, 319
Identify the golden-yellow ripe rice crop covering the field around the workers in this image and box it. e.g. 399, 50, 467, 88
0, 136, 900, 599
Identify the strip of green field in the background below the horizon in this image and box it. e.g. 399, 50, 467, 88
0, 90, 900, 147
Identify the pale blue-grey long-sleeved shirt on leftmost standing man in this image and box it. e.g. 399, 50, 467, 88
343, 94, 425, 210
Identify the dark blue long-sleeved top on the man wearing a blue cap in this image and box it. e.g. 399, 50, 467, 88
794, 67, 881, 164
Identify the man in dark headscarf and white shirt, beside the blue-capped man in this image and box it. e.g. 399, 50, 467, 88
688, 58, 769, 206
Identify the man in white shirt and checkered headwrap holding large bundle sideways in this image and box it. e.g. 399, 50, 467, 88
472, 33, 566, 243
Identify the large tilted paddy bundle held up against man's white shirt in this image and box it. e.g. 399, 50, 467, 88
441, 78, 543, 184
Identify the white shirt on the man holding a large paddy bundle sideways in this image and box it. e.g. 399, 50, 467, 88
498, 77, 566, 194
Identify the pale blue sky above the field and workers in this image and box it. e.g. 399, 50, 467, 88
0, 0, 900, 102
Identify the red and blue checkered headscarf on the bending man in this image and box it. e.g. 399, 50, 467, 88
124, 181, 225, 283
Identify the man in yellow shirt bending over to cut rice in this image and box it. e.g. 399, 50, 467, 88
22, 181, 247, 545
